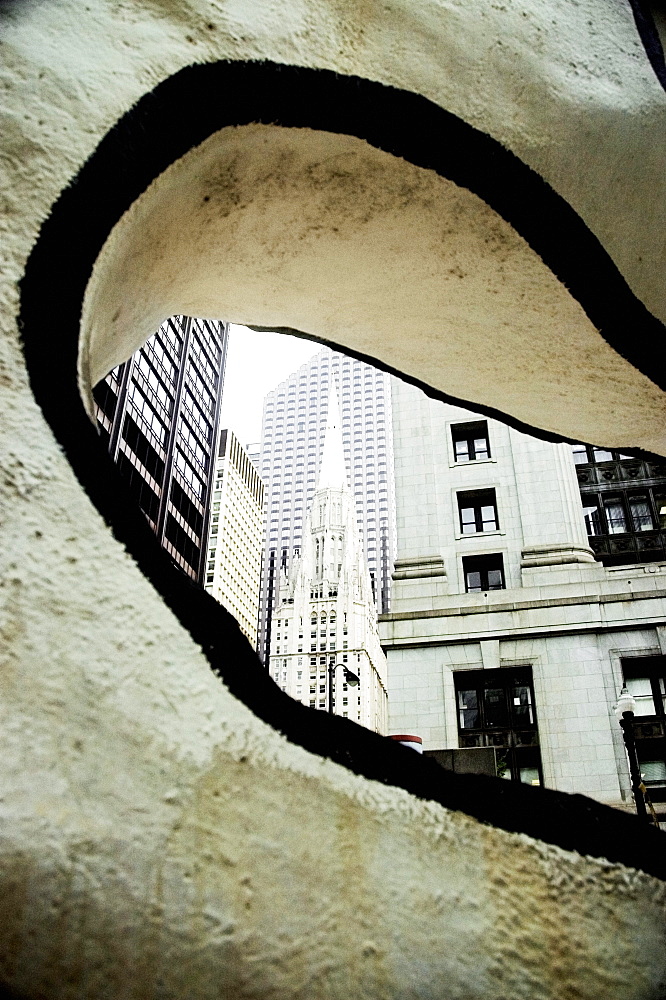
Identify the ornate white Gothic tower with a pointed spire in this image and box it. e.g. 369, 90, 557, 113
270, 388, 388, 733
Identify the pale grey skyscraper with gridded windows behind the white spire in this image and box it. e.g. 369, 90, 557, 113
258, 347, 395, 662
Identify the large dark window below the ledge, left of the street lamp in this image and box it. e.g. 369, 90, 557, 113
454, 667, 543, 785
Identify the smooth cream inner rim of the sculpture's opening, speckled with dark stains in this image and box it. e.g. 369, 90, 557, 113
82, 125, 666, 451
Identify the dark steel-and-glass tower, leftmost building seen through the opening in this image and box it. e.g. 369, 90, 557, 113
93, 316, 228, 583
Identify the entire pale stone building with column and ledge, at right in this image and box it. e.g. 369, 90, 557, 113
380, 380, 666, 810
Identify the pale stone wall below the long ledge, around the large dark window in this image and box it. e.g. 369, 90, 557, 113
388, 609, 663, 804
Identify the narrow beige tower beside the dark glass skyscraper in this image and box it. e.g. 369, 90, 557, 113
204, 430, 264, 649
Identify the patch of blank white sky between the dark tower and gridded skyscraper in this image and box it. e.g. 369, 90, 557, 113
220, 325, 321, 447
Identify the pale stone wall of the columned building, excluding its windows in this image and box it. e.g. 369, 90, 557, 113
381, 380, 666, 803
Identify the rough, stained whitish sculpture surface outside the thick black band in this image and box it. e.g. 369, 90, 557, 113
0, 0, 666, 1000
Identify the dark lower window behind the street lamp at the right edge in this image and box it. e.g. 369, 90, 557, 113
622, 656, 666, 802
